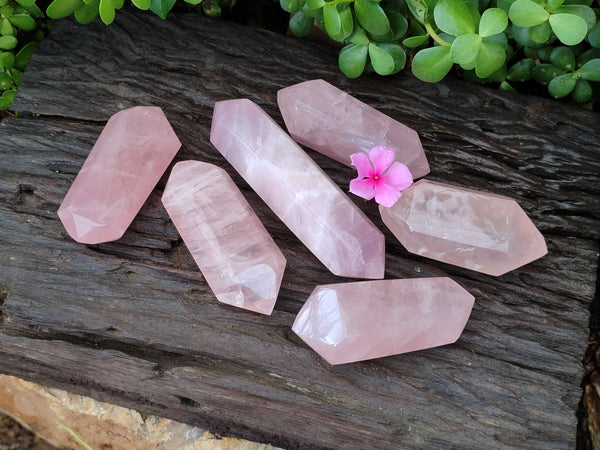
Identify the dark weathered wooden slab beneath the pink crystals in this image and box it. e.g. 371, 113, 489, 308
0, 7, 600, 449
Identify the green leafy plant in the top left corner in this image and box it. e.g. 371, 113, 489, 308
0, 0, 44, 110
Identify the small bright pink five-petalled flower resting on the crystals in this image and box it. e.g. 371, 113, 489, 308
350, 145, 413, 207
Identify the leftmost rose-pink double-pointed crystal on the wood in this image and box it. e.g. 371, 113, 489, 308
58, 106, 181, 244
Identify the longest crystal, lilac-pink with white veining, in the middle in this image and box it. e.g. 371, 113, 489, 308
210, 99, 385, 278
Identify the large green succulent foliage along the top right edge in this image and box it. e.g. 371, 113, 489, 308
280, 0, 600, 108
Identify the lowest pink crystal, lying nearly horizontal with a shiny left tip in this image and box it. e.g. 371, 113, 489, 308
292, 278, 475, 364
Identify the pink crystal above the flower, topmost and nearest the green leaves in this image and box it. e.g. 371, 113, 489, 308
277, 80, 429, 178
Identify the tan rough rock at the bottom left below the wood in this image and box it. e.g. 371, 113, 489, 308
0, 375, 276, 450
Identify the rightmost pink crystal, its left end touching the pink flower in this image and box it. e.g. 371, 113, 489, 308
379, 180, 548, 276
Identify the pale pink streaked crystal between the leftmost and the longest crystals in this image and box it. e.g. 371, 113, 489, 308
162, 161, 286, 314
